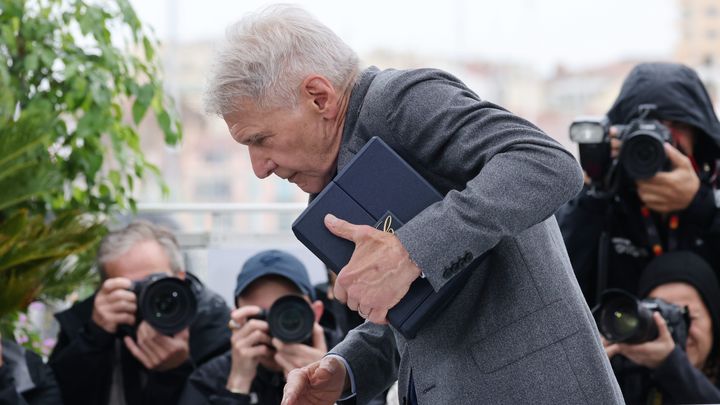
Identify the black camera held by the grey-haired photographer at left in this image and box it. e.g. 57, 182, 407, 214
130, 273, 197, 336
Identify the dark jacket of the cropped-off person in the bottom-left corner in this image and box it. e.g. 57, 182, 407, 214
0, 339, 63, 405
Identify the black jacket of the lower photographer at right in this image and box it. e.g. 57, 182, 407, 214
612, 346, 720, 405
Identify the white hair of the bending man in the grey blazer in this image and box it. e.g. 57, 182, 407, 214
204, 4, 359, 115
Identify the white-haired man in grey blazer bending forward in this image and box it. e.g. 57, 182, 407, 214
207, 6, 623, 404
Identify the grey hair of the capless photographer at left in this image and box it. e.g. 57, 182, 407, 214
97, 220, 185, 278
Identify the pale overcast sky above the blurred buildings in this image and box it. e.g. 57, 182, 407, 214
131, 0, 680, 70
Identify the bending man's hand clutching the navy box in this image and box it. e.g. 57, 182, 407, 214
325, 214, 420, 324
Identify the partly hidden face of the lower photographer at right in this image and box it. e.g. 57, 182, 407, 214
648, 283, 713, 369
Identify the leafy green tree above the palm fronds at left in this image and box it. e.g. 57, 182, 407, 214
0, 0, 181, 213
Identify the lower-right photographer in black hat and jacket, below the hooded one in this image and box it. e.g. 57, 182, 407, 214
603, 252, 720, 404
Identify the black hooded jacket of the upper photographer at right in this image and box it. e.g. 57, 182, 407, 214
556, 63, 720, 307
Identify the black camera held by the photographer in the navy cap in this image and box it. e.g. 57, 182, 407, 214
249, 294, 315, 346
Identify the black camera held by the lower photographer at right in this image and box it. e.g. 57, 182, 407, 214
593, 289, 690, 350
